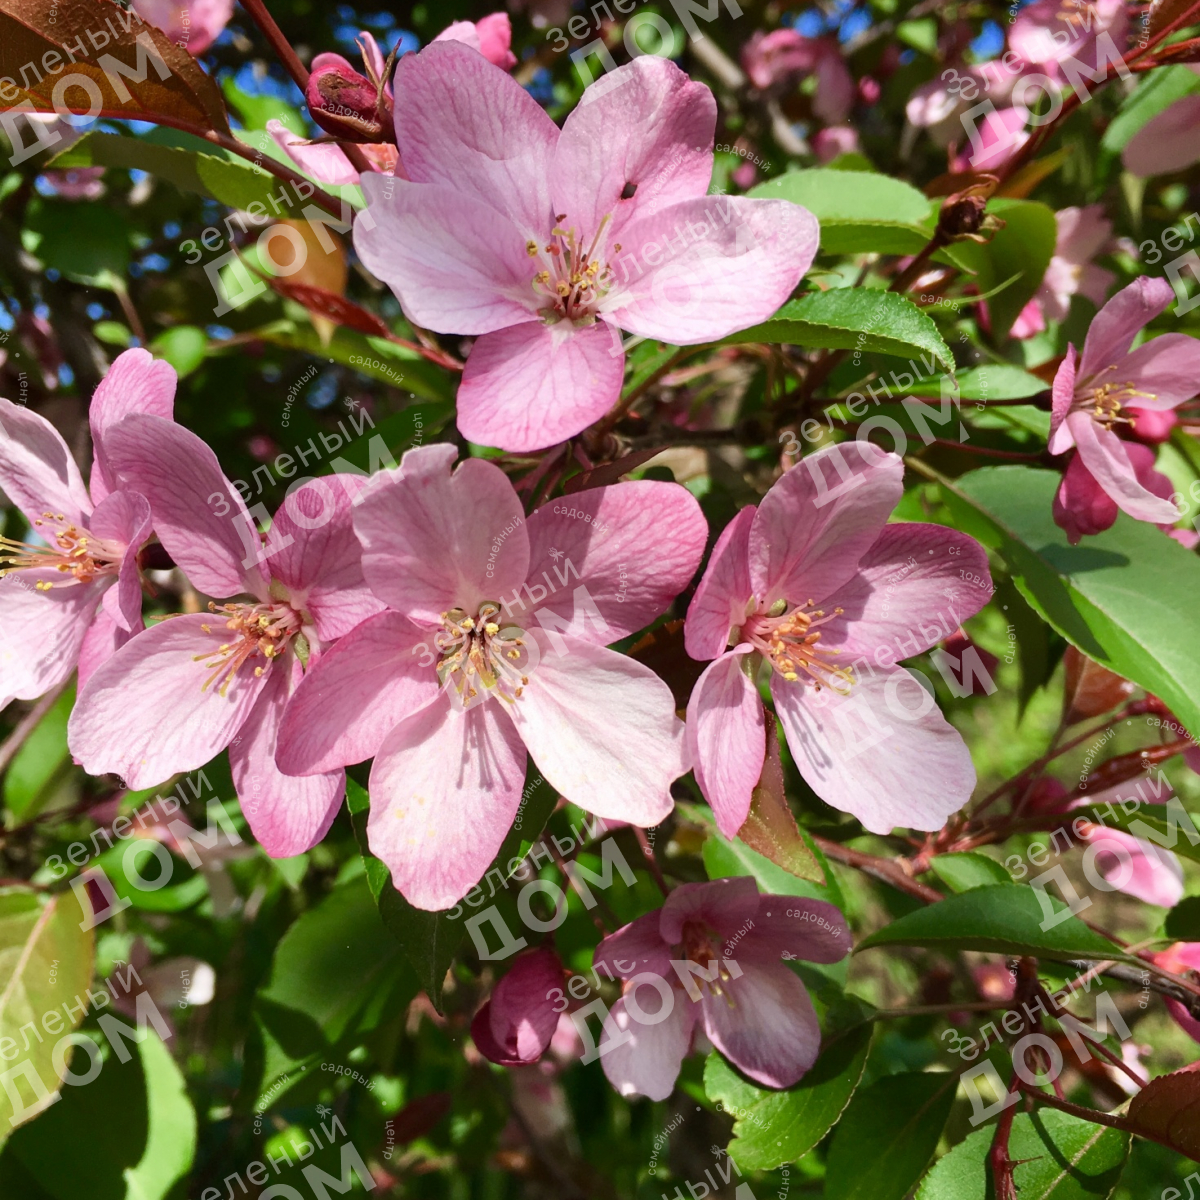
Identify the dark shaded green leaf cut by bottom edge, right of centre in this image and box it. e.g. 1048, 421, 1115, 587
824, 1072, 959, 1200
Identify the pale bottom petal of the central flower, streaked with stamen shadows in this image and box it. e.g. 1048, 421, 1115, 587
367, 695, 526, 911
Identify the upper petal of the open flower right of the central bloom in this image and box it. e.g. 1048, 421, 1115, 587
750, 442, 904, 608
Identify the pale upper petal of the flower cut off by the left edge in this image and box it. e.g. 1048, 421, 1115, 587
0, 400, 91, 527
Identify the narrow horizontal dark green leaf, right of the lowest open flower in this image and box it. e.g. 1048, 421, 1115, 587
854, 883, 1126, 959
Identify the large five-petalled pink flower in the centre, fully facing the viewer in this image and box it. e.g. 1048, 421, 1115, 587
278, 444, 706, 910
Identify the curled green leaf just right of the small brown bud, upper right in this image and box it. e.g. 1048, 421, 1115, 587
934, 199, 1058, 343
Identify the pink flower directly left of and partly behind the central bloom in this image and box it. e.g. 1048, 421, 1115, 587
67, 416, 380, 858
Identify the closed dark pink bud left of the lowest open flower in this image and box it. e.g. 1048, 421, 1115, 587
470, 946, 563, 1067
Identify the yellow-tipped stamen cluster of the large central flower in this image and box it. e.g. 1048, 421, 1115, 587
434, 600, 530, 709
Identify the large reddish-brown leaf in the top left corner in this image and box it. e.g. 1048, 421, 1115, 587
0, 0, 232, 137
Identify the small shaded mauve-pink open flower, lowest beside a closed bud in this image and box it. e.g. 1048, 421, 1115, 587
594, 876, 851, 1100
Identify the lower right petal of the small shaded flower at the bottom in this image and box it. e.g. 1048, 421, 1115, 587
700, 962, 821, 1087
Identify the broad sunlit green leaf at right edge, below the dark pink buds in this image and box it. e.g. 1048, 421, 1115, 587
942, 467, 1200, 734
